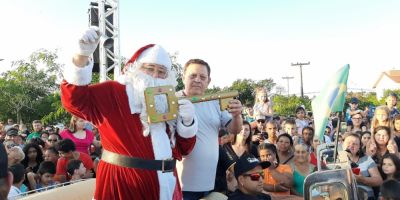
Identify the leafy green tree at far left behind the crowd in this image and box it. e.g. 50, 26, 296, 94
0, 49, 61, 122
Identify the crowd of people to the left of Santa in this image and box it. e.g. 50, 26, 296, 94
0, 117, 101, 199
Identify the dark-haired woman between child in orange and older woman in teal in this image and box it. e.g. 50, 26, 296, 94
276, 133, 294, 164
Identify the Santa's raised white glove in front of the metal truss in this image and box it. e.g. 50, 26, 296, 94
78, 26, 100, 56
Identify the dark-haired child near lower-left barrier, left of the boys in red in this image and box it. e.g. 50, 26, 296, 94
27, 161, 56, 192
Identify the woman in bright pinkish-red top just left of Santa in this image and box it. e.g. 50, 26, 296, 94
60, 116, 99, 154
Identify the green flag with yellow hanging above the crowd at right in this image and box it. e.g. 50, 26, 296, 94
311, 64, 350, 142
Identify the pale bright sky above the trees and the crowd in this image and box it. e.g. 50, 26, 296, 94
0, 0, 400, 96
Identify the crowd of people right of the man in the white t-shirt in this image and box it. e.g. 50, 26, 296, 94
216, 92, 400, 199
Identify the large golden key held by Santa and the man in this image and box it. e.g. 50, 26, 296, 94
144, 86, 239, 123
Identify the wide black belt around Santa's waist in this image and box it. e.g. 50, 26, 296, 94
101, 149, 176, 173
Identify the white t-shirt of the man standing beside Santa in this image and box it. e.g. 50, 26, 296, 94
176, 93, 232, 192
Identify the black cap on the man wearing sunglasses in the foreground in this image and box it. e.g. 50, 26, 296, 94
235, 153, 271, 179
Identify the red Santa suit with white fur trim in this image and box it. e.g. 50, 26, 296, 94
61, 44, 197, 200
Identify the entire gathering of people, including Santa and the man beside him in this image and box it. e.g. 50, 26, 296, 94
0, 27, 400, 200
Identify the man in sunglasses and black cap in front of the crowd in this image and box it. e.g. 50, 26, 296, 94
228, 154, 271, 200
